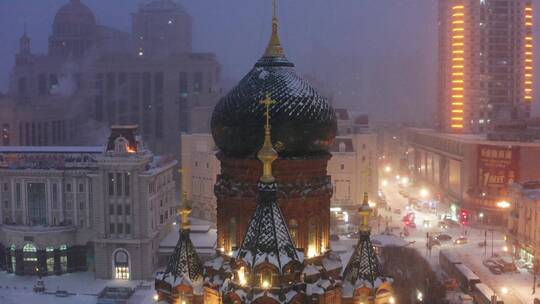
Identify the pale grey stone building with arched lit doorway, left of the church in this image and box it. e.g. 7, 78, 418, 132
0, 126, 176, 279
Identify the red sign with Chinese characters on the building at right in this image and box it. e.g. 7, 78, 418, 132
478, 145, 519, 188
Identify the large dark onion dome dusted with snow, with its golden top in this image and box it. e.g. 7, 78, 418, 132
211, 12, 337, 157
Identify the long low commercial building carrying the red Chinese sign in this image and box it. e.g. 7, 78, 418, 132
406, 129, 540, 224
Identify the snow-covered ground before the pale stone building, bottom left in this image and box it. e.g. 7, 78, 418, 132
0, 272, 154, 304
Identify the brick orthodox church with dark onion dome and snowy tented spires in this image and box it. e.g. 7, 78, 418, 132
155, 2, 395, 304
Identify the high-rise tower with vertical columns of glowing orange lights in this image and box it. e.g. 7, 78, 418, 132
438, 0, 533, 133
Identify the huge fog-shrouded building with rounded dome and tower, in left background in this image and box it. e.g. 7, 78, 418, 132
0, 0, 221, 155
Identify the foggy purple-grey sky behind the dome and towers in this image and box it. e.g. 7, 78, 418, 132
0, 0, 540, 122
